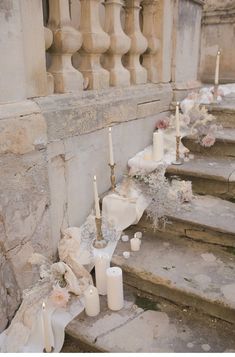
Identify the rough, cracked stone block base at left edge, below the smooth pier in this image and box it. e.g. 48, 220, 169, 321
0, 101, 53, 331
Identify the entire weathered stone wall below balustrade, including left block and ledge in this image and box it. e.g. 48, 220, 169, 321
0, 84, 172, 331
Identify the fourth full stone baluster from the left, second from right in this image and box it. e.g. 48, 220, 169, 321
124, 0, 148, 84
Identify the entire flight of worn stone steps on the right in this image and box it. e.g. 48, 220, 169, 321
63, 98, 235, 352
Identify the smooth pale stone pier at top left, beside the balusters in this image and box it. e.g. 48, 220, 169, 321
0, 0, 47, 103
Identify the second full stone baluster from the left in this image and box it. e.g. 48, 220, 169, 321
79, 0, 110, 89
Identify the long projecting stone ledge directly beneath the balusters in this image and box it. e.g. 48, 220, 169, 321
34, 84, 172, 141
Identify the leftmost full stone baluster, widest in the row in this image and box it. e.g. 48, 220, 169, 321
48, 0, 83, 93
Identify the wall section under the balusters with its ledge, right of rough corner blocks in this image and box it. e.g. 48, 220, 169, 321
35, 84, 172, 248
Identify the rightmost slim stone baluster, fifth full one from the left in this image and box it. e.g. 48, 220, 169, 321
143, 0, 160, 83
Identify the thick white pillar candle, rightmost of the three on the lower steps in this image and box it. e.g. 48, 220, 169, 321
106, 267, 124, 311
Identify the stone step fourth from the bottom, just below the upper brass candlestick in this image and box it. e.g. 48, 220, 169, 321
166, 155, 235, 199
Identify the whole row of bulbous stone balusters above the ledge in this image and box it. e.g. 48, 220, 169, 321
41, 0, 160, 93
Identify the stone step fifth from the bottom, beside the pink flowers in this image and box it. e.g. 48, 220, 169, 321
182, 128, 235, 157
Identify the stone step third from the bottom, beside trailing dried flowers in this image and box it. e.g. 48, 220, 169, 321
139, 196, 235, 248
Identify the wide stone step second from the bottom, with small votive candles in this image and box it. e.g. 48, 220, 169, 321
112, 227, 235, 323
